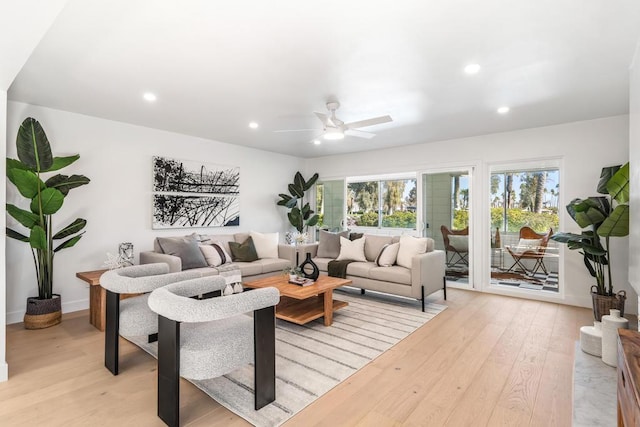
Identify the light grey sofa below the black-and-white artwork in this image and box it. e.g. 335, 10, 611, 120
140, 233, 296, 282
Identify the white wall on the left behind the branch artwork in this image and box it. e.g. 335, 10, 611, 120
3, 102, 303, 323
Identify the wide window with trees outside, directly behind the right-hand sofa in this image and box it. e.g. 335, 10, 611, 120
347, 177, 417, 229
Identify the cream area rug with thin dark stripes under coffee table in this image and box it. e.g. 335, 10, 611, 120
129, 291, 447, 426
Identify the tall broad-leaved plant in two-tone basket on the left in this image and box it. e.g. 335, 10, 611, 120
6, 117, 89, 329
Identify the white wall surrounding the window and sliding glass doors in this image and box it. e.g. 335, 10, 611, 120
306, 116, 638, 313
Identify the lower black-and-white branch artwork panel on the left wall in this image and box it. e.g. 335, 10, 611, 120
153, 194, 240, 229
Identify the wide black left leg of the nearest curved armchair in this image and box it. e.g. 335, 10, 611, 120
158, 316, 180, 427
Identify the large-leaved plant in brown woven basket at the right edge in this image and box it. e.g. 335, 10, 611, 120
551, 162, 629, 321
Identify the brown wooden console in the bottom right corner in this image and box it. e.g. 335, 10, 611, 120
618, 329, 640, 427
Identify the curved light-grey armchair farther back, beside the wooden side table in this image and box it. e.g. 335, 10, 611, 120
100, 263, 202, 375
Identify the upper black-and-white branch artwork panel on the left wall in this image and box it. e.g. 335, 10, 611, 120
153, 156, 240, 195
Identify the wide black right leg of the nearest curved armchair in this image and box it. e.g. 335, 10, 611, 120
253, 306, 276, 411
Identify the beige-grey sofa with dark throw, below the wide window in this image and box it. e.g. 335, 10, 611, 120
302, 234, 447, 310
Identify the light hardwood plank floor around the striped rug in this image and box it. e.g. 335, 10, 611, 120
0, 289, 592, 427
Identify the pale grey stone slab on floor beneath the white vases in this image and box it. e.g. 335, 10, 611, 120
573, 342, 618, 427
